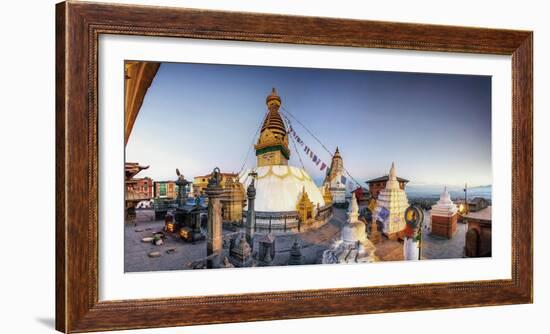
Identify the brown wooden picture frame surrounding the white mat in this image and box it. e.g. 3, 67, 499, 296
56, 1, 533, 332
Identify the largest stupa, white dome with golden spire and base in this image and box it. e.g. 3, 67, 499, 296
239, 88, 332, 233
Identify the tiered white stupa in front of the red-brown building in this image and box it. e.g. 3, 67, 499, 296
374, 162, 409, 239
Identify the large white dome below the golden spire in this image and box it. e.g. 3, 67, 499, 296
239, 165, 325, 212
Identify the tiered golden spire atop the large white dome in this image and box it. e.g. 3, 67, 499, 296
254, 88, 290, 166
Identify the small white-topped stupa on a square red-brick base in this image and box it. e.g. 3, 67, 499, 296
430, 187, 458, 239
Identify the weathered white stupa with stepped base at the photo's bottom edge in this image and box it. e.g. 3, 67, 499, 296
323, 193, 379, 264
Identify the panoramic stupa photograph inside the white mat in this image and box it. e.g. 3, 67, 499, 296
126, 60, 498, 273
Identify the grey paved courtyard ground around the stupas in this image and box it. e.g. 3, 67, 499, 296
124, 209, 474, 272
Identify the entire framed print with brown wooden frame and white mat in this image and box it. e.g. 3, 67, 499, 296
56, 1, 533, 332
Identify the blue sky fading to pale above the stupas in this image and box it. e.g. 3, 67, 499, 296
126, 63, 492, 186
